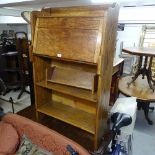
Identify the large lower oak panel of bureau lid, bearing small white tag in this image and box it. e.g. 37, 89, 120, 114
33, 28, 98, 62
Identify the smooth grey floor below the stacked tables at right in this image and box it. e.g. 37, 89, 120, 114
133, 104, 155, 155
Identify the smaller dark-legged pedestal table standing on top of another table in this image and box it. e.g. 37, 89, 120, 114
123, 47, 155, 91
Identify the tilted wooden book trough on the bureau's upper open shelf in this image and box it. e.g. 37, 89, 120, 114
47, 67, 95, 91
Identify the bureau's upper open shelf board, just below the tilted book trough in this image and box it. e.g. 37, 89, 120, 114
36, 81, 97, 102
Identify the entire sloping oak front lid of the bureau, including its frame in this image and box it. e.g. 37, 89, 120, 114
33, 16, 103, 63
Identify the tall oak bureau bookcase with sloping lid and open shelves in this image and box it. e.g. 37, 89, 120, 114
31, 4, 118, 148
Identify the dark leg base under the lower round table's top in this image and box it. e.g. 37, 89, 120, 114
137, 101, 154, 125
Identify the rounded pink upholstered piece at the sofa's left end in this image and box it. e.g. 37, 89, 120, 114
0, 122, 19, 155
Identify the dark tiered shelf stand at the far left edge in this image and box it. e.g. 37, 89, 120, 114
0, 38, 20, 90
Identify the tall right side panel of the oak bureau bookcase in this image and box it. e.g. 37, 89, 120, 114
95, 5, 119, 147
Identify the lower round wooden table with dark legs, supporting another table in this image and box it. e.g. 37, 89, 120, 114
118, 76, 155, 125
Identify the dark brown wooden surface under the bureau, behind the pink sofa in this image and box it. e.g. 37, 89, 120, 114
18, 105, 93, 151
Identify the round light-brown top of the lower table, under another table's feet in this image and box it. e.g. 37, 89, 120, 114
118, 76, 155, 102
